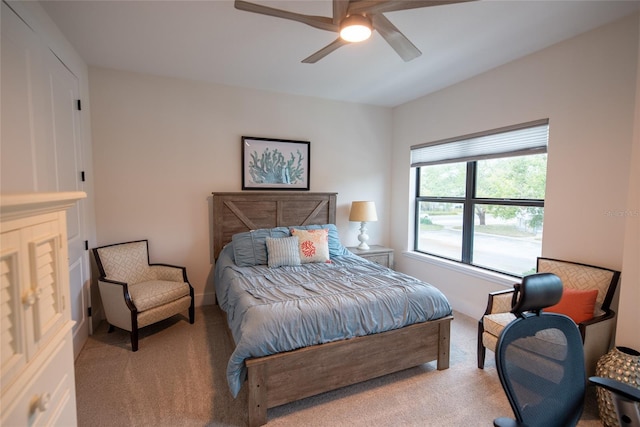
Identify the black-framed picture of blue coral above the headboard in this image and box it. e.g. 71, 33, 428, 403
242, 136, 311, 191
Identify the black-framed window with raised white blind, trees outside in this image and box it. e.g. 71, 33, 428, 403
411, 119, 549, 277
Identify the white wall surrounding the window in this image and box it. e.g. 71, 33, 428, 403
391, 10, 640, 340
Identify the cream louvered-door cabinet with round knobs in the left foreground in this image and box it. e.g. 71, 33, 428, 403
0, 192, 85, 426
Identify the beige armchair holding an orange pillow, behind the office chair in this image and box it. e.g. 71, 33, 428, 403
478, 257, 620, 376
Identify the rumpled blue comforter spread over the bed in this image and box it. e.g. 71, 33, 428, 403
214, 244, 451, 397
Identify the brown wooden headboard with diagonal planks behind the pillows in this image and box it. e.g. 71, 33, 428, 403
213, 191, 337, 259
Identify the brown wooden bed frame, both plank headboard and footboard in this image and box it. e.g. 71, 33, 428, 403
213, 191, 453, 427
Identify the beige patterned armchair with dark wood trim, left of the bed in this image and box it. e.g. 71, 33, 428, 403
93, 240, 195, 351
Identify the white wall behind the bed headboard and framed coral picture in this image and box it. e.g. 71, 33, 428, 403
89, 68, 391, 304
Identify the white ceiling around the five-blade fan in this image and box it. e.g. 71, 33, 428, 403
41, 0, 640, 106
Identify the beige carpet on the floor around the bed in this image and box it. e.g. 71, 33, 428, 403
76, 306, 602, 427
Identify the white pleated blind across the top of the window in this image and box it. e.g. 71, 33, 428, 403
411, 119, 549, 167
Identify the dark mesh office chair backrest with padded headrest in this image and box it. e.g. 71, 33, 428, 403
495, 273, 586, 427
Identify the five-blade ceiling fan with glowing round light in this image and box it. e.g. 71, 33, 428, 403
235, 0, 473, 64
